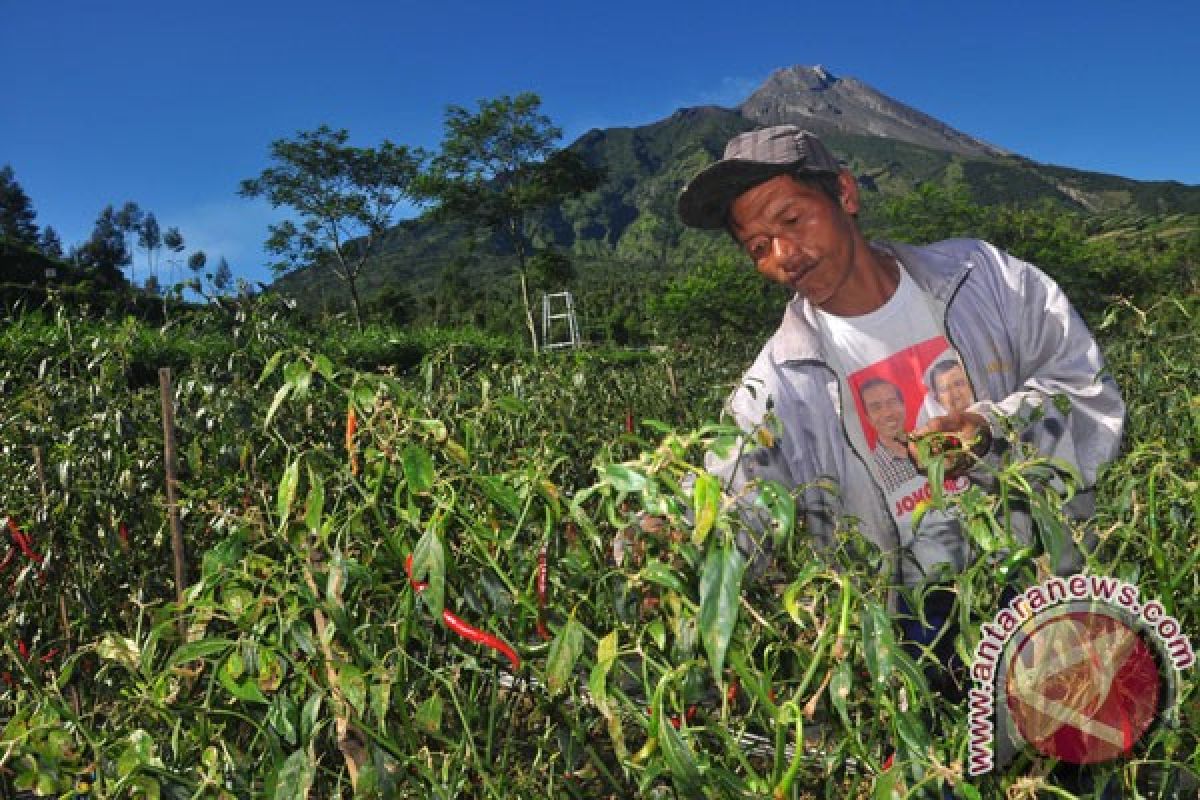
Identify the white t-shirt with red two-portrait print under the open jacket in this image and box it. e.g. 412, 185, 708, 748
816, 266, 967, 539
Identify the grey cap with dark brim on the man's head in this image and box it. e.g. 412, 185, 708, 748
679, 125, 841, 228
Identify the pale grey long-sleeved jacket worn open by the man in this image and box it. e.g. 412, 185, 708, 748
706, 239, 1124, 585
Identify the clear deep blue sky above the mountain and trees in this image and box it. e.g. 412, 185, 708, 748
0, 0, 1200, 287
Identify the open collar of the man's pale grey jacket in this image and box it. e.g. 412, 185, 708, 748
772, 241, 974, 363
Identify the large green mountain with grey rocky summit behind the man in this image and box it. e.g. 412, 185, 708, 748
276, 66, 1200, 302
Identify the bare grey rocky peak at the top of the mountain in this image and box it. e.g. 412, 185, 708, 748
738, 65, 1008, 157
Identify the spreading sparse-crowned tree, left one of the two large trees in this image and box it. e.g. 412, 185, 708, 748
239, 125, 424, 330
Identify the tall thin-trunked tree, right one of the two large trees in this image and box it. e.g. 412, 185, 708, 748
420, 92, 600, 351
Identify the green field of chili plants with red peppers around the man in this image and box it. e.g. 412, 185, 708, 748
0, 291, 1200, 800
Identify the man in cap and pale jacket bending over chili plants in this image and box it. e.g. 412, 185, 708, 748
679, 125, 1124, 585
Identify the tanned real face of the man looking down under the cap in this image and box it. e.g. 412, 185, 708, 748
730, 173, 869, 314
